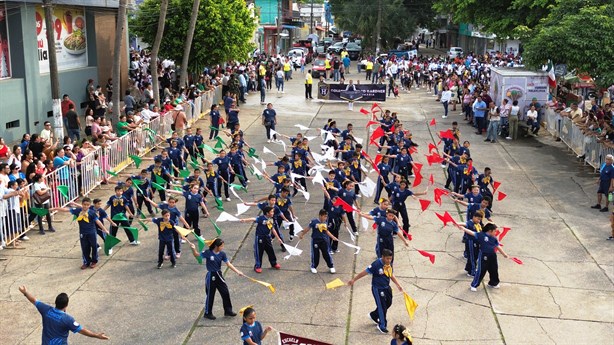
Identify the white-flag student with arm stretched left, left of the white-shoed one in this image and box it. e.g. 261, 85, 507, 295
239, 206, 283, 273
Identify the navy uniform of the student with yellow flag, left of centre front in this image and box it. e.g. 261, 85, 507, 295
200, 249, 232, 315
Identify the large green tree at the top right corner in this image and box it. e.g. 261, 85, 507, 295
523, 0, 614, 86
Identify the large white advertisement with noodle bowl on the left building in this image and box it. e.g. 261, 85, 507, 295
36, 6, 87, 73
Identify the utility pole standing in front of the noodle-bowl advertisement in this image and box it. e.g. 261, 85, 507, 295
43, 0, 64, 139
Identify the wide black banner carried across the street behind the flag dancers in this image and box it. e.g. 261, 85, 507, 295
318, 83, 386, 102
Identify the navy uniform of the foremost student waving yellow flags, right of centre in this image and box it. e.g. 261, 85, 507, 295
366, 259, 392, 329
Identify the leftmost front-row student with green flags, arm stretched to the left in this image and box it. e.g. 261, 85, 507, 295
49, 197, 109, 270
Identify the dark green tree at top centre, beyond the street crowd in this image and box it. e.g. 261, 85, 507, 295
330, 0, 417, 50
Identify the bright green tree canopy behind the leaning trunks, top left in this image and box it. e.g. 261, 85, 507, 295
129, 0, 256, 73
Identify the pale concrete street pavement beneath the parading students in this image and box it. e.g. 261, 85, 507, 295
0, 68, 614, 345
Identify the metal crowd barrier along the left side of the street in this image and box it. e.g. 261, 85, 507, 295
0, 87, 222, 248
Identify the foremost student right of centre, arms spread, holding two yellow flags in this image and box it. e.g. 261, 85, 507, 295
348, 249, 405, 333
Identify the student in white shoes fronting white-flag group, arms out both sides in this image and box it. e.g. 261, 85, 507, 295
299, 209, 339, 274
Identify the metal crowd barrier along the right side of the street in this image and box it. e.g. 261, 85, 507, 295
545, 109, 614, 170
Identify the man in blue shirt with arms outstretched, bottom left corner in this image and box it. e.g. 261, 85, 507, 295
19, 286, 109, 345
